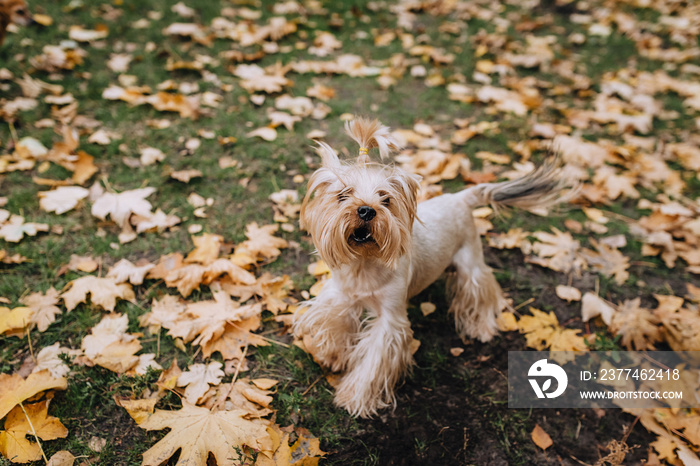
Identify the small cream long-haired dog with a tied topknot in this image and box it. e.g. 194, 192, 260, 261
294, 119, 567, 417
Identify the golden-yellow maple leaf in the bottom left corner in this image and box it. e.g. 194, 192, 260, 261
0, 400, 68, 463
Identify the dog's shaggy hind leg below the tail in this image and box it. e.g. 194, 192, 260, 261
448, 240, 505, 342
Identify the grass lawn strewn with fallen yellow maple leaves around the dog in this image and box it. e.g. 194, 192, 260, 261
0, 0, 700, 466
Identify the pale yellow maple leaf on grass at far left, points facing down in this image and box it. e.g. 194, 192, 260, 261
61, 276, 135, 312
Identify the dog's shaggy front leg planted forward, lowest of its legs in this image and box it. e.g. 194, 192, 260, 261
335, 293, 413, 417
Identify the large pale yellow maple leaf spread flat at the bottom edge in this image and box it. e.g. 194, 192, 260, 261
139, 401, 272, 466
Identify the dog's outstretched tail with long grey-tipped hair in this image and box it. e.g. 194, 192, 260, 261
462, 156, 578, 212
